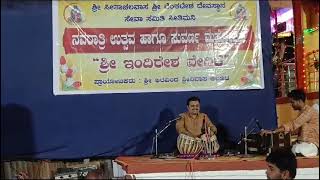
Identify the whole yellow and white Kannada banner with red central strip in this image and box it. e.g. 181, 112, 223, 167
52, 0, 264, 95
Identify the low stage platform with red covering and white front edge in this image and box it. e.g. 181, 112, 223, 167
114, 156, 319, 179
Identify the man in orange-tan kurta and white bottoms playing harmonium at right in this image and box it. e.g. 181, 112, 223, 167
261, 90, 319, 156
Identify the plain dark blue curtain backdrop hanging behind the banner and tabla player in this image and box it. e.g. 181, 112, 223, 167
1, 1, 276, 159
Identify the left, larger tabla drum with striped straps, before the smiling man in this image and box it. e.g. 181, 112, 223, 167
177, 134, 202, 154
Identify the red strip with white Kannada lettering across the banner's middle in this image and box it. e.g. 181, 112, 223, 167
63, 26, 254, 54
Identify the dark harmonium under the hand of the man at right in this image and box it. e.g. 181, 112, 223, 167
247, 132, 292, 154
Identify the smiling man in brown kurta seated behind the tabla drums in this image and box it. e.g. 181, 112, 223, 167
176, 96, 219, 152
